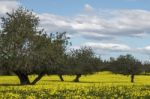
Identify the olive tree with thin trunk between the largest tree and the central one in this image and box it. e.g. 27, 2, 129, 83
48, 32, 71, 81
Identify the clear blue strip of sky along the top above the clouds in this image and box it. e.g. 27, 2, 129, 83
20, 0, 150, 13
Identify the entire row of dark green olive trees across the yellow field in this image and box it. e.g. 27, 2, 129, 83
0, 7, 150, 85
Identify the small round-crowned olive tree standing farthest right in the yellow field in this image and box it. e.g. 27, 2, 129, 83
108, 54, 142, 83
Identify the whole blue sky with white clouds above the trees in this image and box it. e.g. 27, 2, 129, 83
0, 0, 150, 61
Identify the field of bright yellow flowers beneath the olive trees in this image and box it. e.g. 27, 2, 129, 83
0, 72, 150, 99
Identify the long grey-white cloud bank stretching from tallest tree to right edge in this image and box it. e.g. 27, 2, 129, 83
39, 7, 150, 40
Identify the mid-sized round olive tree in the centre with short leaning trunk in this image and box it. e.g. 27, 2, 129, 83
68, 47, 101, 82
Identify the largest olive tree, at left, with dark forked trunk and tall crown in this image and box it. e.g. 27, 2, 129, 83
0, 7, 68, 85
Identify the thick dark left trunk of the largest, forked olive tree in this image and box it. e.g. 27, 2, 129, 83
15, 71, 30, 85
